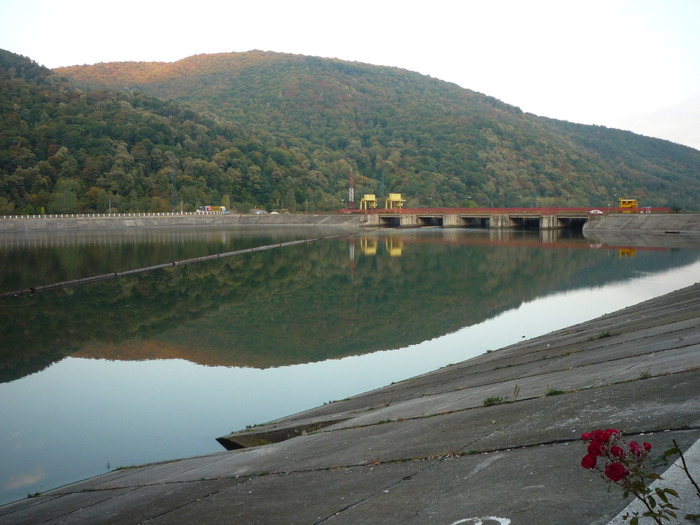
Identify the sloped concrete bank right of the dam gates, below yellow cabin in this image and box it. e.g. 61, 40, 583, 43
583, 213, 700, 235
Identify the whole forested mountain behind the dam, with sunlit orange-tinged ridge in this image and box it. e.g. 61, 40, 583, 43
0, 51, 700, 213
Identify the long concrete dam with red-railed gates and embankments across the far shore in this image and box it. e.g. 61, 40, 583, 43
0, 208, 700, 233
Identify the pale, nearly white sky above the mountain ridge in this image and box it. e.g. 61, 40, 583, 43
0, 0, 700, 149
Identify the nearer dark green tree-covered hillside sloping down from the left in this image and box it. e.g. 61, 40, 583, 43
0, 52, 349, 214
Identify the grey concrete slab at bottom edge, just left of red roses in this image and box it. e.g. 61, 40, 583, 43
312, 445, 623, 525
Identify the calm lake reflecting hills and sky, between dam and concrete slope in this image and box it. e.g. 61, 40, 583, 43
0, 227, 700, 503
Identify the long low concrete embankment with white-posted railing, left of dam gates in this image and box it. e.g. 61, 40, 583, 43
0, 213, 365, 232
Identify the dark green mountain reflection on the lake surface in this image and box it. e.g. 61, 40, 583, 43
0, 229, 698, 381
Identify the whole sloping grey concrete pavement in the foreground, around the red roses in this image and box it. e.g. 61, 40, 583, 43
0, 285, 700, 525
